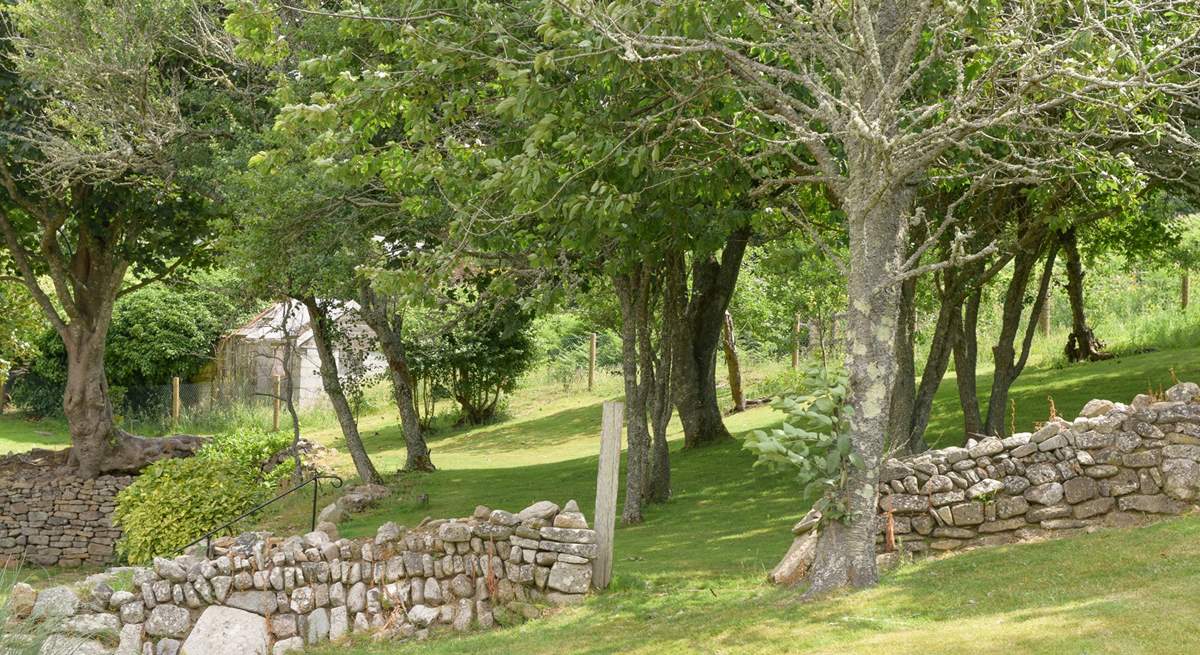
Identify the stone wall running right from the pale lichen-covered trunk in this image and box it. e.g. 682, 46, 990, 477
877, 383, 1200, 553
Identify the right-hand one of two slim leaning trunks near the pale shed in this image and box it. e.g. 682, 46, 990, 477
359, 282, 434, 470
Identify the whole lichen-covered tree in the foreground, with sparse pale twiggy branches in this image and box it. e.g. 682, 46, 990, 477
571, 0, 1196, 594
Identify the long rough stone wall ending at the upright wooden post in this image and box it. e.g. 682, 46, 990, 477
13, 500, 598, 655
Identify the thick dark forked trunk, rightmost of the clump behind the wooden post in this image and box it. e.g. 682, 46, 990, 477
671, 226, 750, 447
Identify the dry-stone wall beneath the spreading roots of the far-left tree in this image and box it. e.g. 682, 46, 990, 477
0, 467, 133, 566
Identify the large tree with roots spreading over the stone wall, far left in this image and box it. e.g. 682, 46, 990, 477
0, 0, 252, 477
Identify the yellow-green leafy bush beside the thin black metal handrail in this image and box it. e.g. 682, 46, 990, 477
114, 432, 293, 564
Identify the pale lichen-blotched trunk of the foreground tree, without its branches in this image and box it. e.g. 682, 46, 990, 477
809, 182, 912, 596
